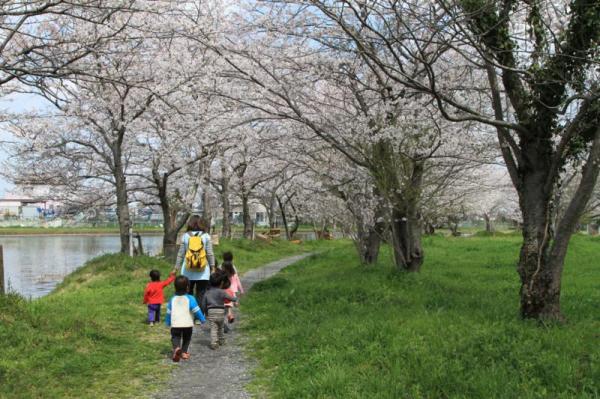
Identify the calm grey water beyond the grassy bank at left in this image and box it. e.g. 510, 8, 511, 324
0, 235, 162, 298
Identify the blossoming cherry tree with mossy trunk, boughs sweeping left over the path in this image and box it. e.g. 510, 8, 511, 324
206, 6, 488, 271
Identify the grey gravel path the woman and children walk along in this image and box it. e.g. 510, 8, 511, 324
156, 253, 311, 399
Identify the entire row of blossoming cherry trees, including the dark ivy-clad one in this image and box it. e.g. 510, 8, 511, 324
0, 0, 600, 318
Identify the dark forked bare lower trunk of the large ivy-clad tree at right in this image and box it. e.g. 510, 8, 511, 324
518, 127, 600, 320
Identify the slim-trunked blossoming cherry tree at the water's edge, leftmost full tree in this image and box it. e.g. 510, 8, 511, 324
4, 4, 209, 252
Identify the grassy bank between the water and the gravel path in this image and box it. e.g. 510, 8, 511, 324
0, 240, 327, 398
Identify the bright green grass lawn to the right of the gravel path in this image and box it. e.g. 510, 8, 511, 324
244, 236, 600, 398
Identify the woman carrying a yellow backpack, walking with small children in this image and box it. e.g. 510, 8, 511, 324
175, 215, 215, 312
